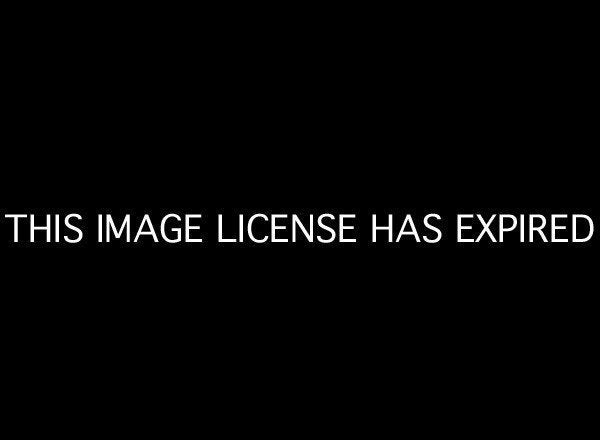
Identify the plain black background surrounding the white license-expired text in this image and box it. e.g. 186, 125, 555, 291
1, 5, 598, 433
